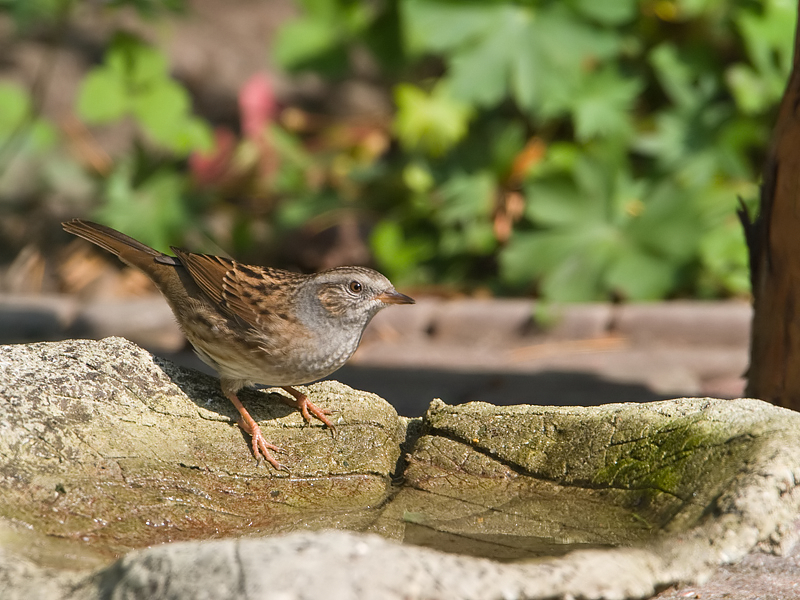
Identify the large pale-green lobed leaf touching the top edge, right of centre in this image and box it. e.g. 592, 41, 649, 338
404, 0, 620, 115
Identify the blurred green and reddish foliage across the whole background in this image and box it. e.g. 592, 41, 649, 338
0, 0, 796, 301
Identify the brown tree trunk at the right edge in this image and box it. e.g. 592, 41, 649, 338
739, 1, 800, 410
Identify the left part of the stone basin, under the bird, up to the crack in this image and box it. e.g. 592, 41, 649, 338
0, 338, 404, 556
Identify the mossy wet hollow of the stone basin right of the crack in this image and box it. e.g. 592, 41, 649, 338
401, 399, 764, 557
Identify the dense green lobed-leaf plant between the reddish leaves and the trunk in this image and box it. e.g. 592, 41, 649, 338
275, 0, 796, 301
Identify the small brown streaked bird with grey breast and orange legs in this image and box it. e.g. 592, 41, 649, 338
62, 219, 414, 470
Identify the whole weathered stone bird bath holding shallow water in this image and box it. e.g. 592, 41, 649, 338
0, 338, 800, 600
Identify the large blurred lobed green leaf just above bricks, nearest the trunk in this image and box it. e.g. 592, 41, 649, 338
500, 147, 703, 302
